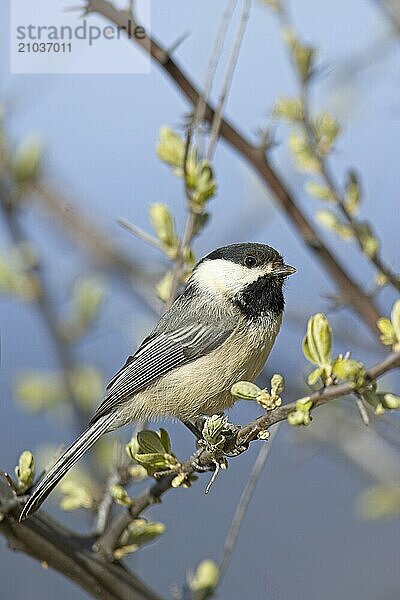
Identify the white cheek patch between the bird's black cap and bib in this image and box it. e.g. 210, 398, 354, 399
193, 259, 266, 296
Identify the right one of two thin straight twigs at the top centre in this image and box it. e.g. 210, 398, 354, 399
206, 0, 251, 160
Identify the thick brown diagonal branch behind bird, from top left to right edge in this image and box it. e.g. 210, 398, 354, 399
86, 0, 379, 335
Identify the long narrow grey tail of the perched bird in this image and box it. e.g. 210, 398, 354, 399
19, 415, 115, 521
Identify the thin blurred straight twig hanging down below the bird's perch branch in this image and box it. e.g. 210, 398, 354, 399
218, 424, 279, 583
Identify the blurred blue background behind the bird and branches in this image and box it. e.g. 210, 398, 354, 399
0, 0, 400, 600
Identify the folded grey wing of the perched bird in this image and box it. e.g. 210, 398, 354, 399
90, 321, 235, 424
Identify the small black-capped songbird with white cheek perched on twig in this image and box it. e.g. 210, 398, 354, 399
20, 243, 296, 520
